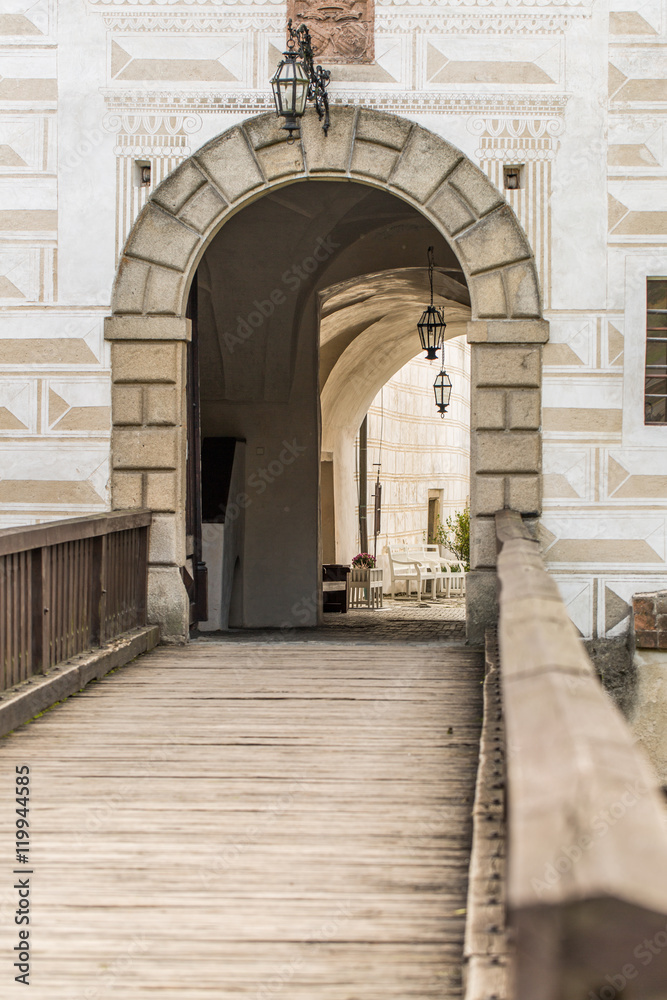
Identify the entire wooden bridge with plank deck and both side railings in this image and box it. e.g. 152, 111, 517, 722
0, 511, 667, 1000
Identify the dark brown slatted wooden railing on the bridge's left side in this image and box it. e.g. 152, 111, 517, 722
0, 510, 151, 690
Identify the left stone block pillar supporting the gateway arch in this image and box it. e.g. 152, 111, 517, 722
104, 316, 191, 642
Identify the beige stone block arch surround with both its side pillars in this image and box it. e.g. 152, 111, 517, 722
105, 108, 548, 641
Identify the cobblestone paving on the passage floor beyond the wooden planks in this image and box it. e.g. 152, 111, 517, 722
194, 597, 466, 644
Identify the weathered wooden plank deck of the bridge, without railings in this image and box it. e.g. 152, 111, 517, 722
0, 642, 482, 1000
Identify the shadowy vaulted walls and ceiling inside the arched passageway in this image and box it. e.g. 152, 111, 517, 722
190, 181, 470, 628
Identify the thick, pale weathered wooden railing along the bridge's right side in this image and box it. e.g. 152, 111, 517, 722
496, 510, 667, 1000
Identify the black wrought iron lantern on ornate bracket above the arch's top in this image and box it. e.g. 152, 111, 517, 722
271, 18, 331, 142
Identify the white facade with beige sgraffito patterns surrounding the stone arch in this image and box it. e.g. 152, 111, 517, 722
0, 0, 667, 636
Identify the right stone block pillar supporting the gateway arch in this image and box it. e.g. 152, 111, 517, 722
467, 320, 549, 643
